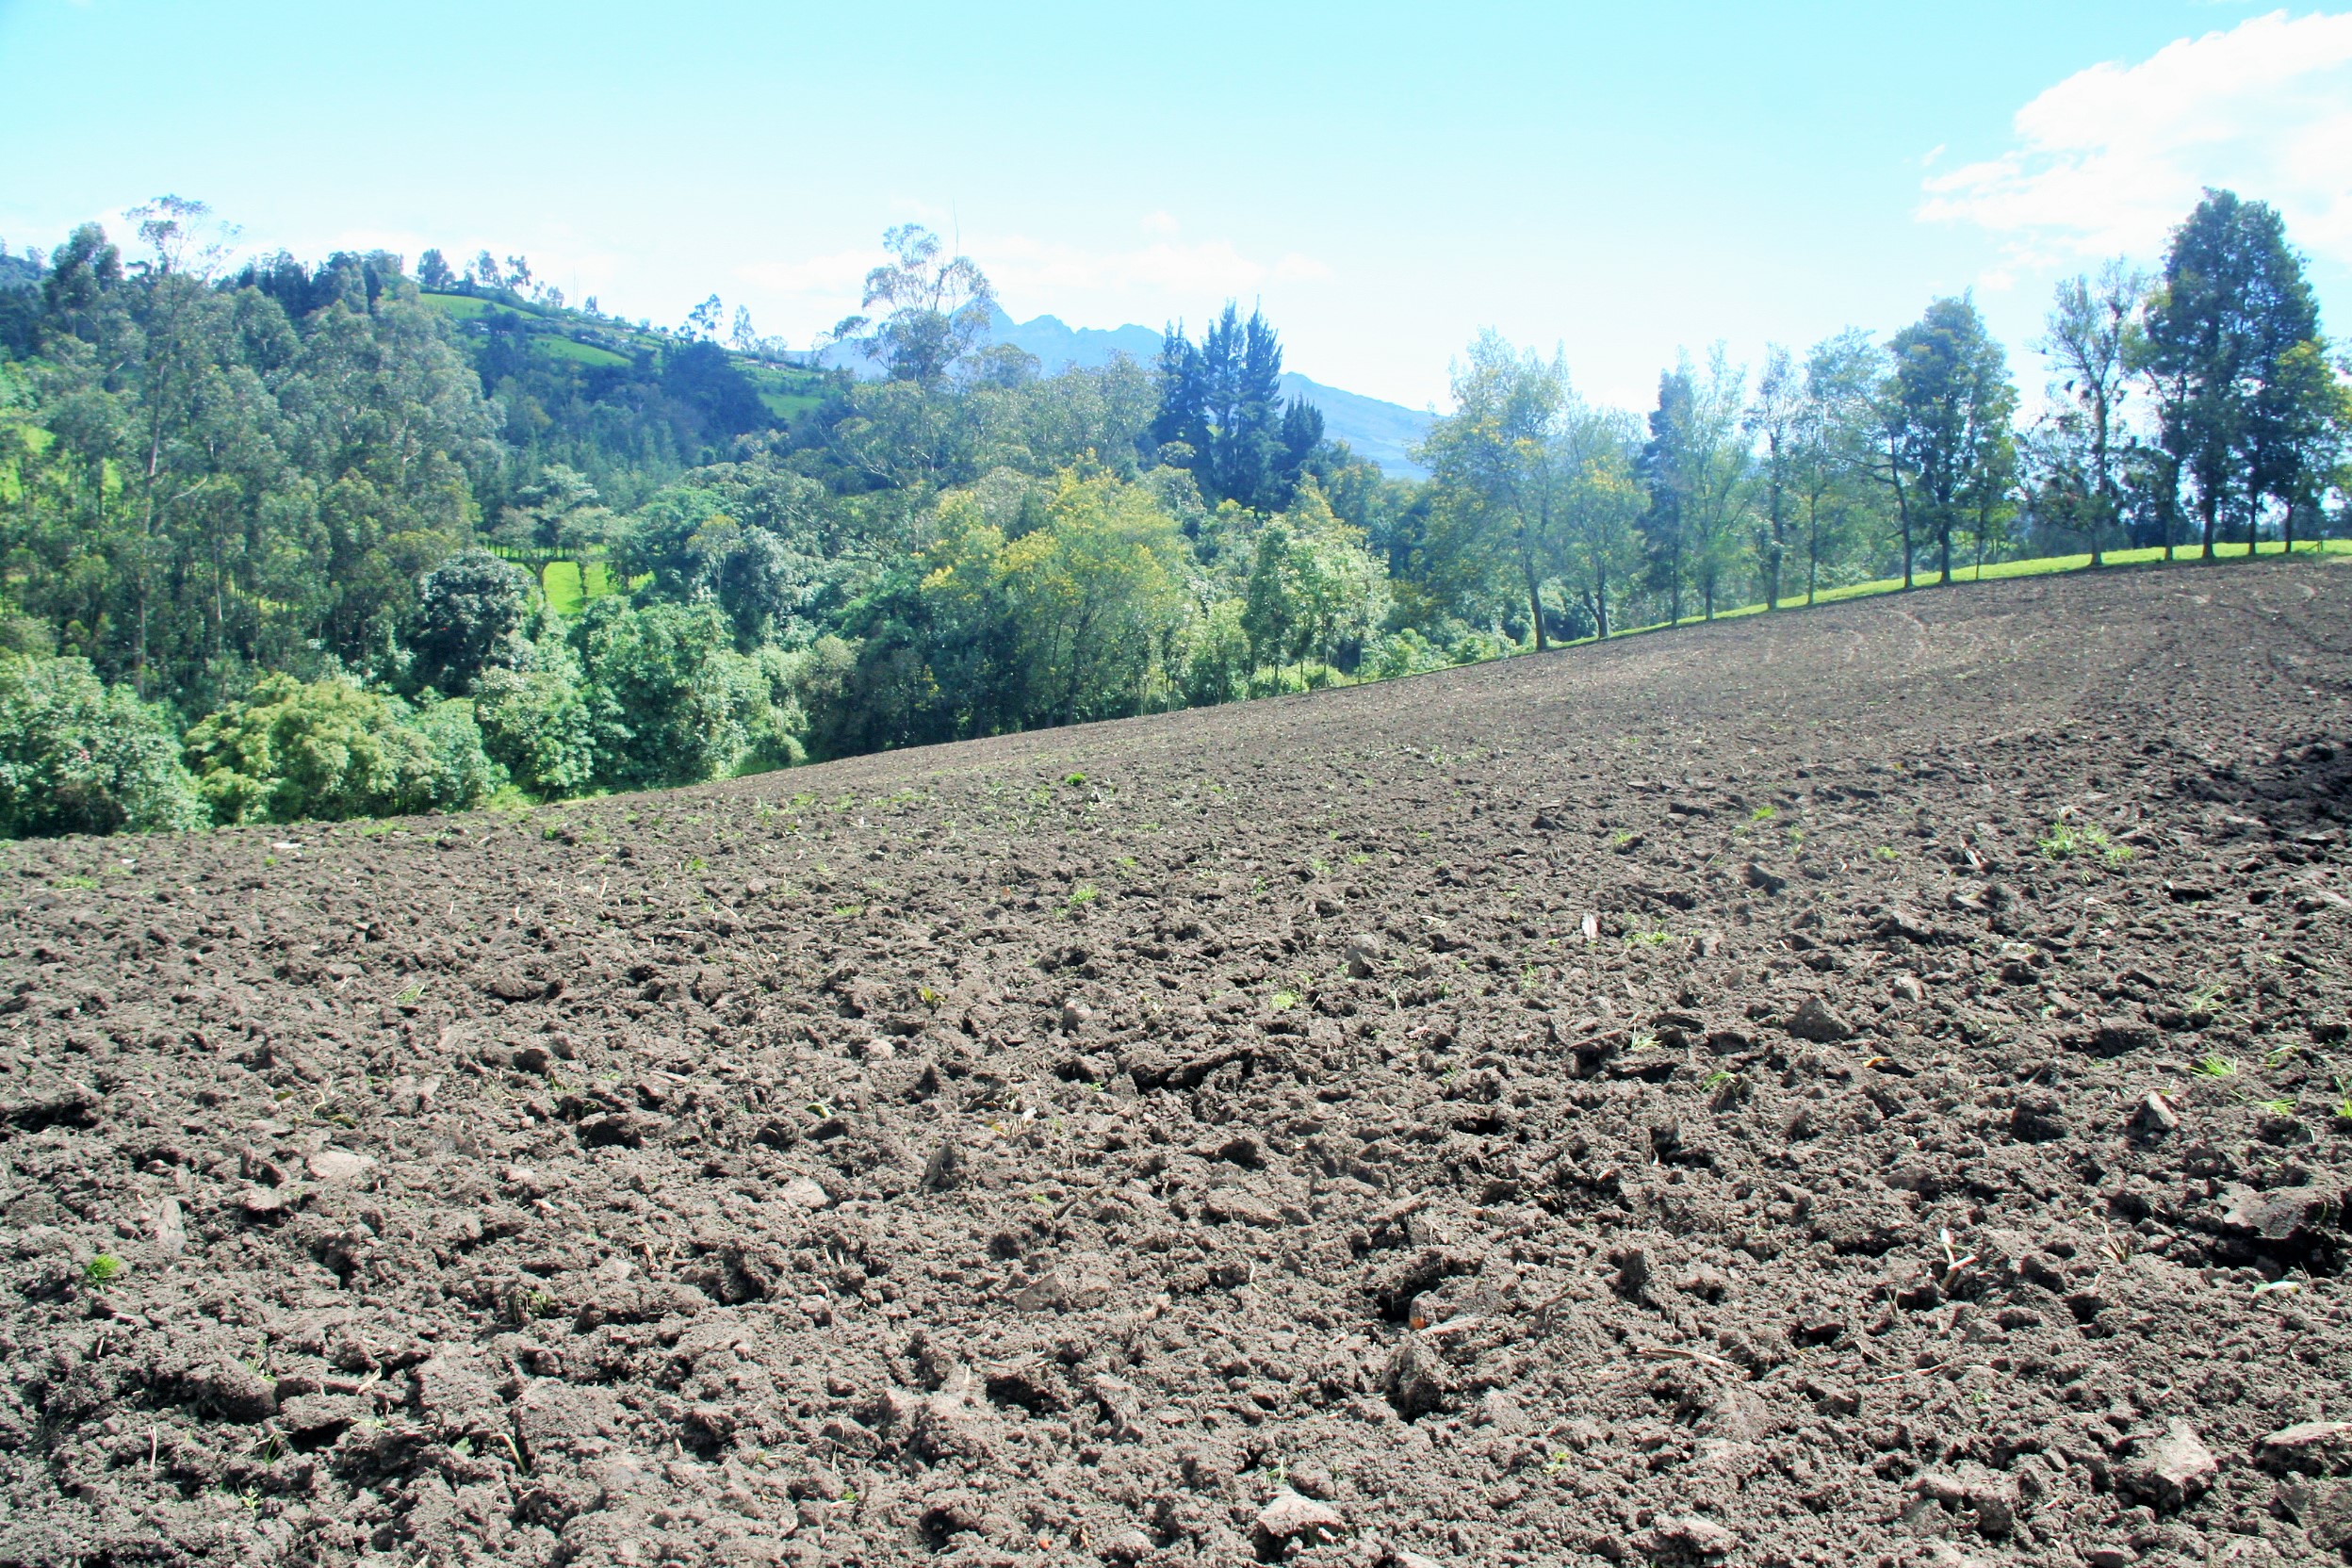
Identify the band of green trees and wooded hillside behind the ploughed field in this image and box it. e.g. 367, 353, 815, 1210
0, 193, 2352, 835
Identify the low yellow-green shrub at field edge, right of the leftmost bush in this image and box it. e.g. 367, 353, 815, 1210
188, 675, 503, 823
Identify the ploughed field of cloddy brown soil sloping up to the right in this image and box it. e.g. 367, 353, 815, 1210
0, 564, 2352, 1566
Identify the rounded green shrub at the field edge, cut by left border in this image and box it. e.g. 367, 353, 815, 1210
0, 654, 207, 840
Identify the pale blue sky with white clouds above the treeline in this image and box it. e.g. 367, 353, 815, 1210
0, 0, 2352, 409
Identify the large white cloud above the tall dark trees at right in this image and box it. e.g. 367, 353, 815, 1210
1919, 11, 2352, 263
